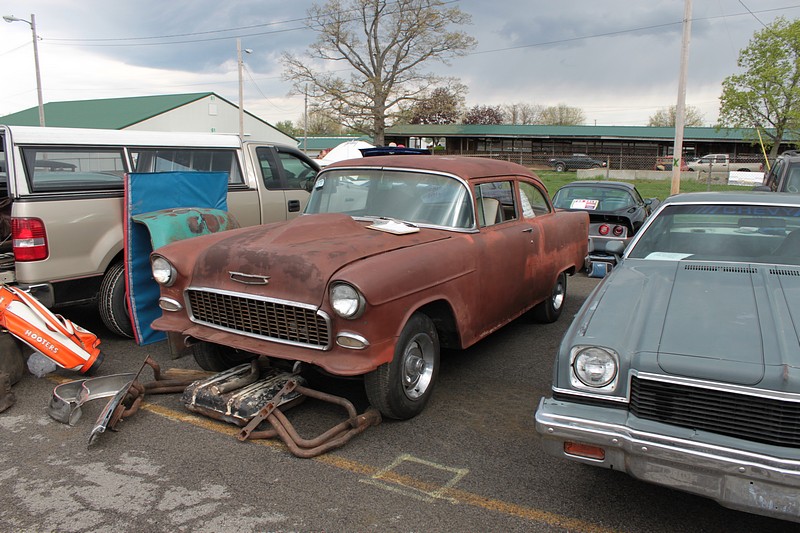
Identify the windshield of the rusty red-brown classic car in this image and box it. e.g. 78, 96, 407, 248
305, 168, 475, 229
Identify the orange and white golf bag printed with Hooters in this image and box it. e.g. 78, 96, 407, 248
0, 285, 103, 374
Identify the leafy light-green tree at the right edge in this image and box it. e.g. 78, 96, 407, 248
719, 17, 800, 158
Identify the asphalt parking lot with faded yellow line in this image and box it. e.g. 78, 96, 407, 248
0, 274, 796, 532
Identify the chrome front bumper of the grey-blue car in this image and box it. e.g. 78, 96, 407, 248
536, 398, 800, 522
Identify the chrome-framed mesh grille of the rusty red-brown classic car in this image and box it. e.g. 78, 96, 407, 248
186, 289, 330, 349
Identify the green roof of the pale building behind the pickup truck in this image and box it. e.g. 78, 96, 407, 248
0, 93, 216, 130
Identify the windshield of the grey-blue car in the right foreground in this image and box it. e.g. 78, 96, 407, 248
628, 204, 800, 265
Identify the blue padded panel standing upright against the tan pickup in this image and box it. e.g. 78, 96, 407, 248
124, 172, 228, 345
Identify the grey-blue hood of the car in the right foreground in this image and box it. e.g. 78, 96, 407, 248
583, 260, 800, 390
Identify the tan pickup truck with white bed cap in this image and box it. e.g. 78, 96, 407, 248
0, 126, 319, 336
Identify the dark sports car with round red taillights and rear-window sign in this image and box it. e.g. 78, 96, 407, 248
553, 181, 660, 271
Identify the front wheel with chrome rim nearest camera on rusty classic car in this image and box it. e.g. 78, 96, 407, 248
364, 313, 439, 420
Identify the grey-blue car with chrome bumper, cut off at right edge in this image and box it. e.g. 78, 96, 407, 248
535, 192, 800, 522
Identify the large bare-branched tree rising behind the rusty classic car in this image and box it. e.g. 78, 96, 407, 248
283, 0, 476, 145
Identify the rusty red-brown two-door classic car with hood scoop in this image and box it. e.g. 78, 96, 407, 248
152, 155, 589, 419
